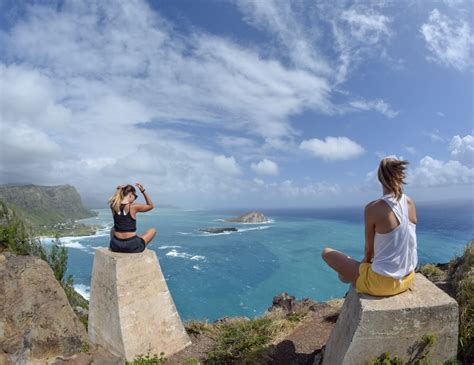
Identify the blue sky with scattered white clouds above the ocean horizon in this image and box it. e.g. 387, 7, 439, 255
0, 0, 474, 209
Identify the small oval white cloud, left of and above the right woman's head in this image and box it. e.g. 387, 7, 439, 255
300, 137, 364, 161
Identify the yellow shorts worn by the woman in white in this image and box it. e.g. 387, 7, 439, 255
355, 262, 415, 296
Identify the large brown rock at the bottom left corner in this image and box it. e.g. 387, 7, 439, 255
0, 252, 87, 364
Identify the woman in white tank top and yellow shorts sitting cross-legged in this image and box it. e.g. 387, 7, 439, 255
322, 158, 418, 296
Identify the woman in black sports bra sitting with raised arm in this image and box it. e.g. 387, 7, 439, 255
108, 183, 156, 253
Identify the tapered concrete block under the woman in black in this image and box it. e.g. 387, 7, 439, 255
89, 248, 191, 361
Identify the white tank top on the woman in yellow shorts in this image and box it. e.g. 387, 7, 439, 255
372, 194, 418, 279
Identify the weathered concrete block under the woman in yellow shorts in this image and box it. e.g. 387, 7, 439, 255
323, 273, 459, 365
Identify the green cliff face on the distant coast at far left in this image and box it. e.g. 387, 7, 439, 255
0, 185, 96, 226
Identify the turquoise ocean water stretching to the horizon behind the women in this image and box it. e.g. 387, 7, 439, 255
39, 203, 474, 321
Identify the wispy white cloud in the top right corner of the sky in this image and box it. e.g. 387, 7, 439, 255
420, 9, 474, 70
